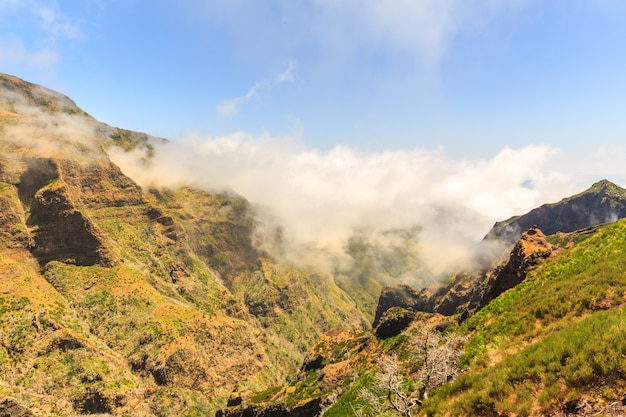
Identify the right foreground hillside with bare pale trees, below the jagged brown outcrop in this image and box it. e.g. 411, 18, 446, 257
225, 221, 626, 417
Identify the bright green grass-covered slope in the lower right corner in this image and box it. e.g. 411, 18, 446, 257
424, 221, 626, 416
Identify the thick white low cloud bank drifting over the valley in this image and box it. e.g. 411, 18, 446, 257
110, 132, 616, 275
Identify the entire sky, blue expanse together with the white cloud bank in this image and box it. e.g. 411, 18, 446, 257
0, 0, 626, 269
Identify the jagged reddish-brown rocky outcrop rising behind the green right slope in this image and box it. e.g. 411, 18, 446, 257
374, 226, 552, 327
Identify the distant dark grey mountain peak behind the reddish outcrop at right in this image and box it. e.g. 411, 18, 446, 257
485, 180, 626, 244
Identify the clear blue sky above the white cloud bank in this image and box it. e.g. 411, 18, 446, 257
0, 0, 626, 158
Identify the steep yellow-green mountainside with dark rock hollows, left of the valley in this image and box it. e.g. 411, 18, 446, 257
0, 75, 363, 416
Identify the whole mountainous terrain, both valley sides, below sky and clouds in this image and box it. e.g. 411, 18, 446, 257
0, 75, 626, 417
